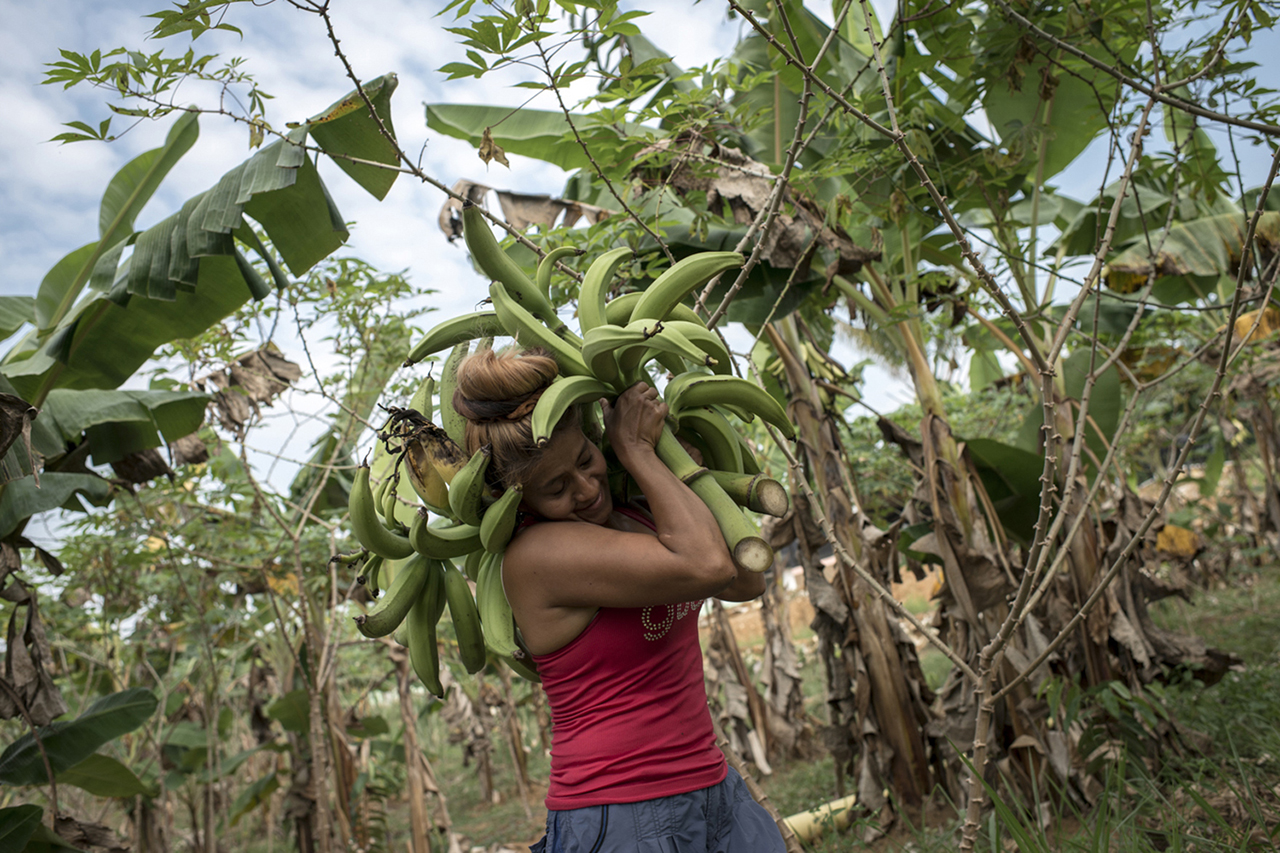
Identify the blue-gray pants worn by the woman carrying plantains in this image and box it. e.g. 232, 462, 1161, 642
529, 767, 786, 853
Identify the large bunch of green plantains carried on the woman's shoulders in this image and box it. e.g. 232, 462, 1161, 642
349, 206, 794, 695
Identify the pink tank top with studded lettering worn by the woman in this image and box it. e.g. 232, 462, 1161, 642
517, 507, 727, 809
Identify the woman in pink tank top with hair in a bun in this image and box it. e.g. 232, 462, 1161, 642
453, 350, 785, 853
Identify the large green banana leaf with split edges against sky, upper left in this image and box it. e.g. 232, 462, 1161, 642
0, 74, 397, 405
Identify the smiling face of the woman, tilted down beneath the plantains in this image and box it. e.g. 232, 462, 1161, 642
524, 428, 613, 524
